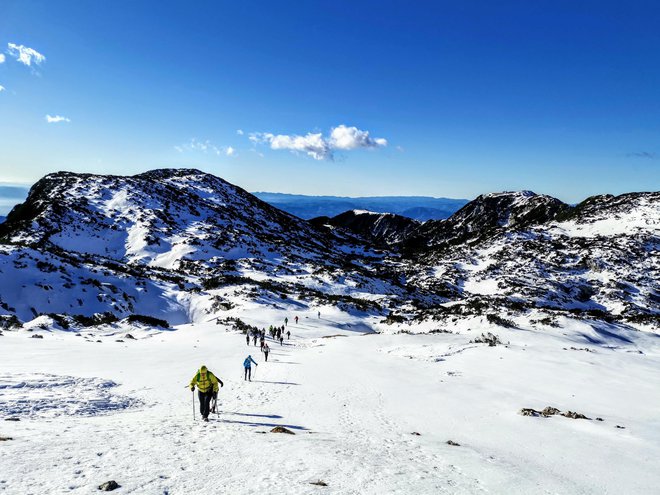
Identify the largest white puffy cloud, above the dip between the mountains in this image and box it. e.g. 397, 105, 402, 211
249, 125, 387, 160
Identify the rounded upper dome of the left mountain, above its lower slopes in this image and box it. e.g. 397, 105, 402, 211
0, 169, 340, 268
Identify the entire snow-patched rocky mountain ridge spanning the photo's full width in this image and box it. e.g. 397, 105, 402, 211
0, 170, 660, 329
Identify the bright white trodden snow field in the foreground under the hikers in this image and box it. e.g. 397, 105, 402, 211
0, 314, 660, 494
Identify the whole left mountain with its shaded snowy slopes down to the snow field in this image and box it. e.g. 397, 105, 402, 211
0, 170, 400, 323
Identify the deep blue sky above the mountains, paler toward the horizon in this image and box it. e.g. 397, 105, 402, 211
0, 0, 660, 202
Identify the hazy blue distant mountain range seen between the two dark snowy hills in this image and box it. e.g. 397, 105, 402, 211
253, 192, 468, 222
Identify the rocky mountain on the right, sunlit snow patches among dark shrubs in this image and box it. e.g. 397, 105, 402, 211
394, 193, 660, 328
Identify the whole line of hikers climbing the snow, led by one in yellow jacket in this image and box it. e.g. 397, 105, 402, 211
189, 318, 302, 421
